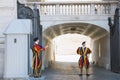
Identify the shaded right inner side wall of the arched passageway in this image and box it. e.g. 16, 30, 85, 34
93, 35, 110, 69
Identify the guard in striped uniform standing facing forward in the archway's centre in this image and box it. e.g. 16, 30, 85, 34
77, 41, 91, 76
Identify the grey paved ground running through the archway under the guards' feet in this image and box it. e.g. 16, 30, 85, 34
0, 62, 120, 80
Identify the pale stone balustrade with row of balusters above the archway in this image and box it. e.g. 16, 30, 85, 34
25, 1, 117, 15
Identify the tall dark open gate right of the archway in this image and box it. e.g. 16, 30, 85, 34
108, 1, 120, 73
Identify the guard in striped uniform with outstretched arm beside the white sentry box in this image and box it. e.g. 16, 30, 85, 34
32, 37, 48, 77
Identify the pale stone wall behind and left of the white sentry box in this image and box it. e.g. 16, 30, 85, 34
0, 0, 17, 77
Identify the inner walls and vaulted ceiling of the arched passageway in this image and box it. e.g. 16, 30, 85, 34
43, 23, 110, 69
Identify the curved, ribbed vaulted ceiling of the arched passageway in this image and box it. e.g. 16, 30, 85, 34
43, 23, 108, 39
